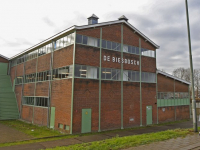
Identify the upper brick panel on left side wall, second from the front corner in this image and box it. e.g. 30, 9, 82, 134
37, 53, 51, 72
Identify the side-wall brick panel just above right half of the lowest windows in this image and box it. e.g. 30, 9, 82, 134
35, 81, 49, 97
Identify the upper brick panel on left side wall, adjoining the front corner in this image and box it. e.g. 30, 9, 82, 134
53, 45, 74, 68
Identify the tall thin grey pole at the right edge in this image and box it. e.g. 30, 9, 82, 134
185, 0, 198, 132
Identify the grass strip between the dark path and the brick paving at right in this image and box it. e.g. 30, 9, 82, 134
47, 129, 193, 150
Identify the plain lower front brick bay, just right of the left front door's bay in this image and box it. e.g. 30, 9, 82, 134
101, 80, 121, 130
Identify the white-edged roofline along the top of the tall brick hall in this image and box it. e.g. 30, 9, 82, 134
10, 20, 160, 60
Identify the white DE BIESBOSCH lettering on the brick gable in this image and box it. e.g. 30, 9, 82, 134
103, 55, 140, 65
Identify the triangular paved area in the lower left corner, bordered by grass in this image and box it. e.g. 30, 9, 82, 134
0, 123, 33, 143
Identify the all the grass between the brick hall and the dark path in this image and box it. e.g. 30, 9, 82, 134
0, 120, 195, 147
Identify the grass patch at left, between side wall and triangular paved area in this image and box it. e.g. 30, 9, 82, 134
0, 120, 64, 138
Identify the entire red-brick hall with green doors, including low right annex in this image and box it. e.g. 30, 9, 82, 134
0, 14, 191, 134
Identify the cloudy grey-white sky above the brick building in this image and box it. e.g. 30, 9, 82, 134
0, 0, 200, 73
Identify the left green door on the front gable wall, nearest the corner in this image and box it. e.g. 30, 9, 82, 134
81, 109, 92, 133
